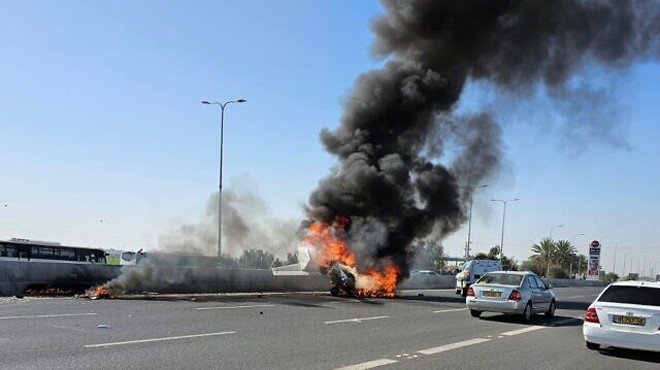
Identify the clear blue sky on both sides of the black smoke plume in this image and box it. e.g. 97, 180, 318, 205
0, 0, 660, 272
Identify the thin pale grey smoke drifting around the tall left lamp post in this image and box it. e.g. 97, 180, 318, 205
106, 181, 298, 293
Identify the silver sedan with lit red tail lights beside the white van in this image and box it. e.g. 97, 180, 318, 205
465, 271, 557, 322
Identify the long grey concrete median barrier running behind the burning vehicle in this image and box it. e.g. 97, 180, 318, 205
0, 261, 607, 296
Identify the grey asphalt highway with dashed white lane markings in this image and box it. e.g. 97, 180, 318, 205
0, 288, 660, 369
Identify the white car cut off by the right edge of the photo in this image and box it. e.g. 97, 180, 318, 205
582, 281, 660, 352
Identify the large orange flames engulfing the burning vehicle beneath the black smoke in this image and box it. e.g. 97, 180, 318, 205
305, 217, 401, 297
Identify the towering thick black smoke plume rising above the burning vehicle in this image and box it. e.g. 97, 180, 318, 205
308, 0, 660, 275
